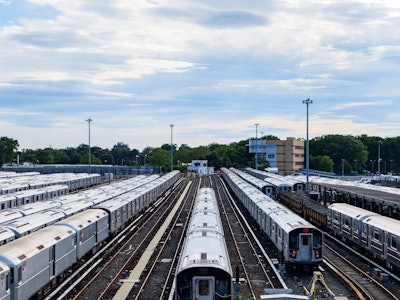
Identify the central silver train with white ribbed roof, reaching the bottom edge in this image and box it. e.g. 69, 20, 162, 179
175, 188, 232, 300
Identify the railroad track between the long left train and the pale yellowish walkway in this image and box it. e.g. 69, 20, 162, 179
46, 177, 188, 299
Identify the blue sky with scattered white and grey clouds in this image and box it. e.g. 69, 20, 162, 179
0, 0, 400, 151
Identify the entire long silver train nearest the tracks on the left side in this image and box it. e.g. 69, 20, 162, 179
0, 171, 180, 300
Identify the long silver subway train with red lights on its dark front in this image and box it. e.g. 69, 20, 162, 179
221, 168, 323, 267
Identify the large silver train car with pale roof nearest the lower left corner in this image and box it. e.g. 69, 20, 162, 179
0, 226, 76, 300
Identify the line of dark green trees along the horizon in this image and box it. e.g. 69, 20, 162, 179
0, 134, 400, 174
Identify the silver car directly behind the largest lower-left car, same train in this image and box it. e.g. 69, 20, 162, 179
52, 209, 109, 259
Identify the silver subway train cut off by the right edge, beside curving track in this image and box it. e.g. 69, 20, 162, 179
327, 203, 400, 271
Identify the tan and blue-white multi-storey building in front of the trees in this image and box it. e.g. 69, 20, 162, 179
249, 137, 305, 175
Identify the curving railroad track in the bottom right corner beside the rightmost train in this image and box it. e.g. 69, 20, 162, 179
324, 239, 400, 300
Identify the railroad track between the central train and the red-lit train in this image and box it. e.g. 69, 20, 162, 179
214, 177, 286, 299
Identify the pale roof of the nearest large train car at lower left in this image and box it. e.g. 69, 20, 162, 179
0, 226, 75, 265
